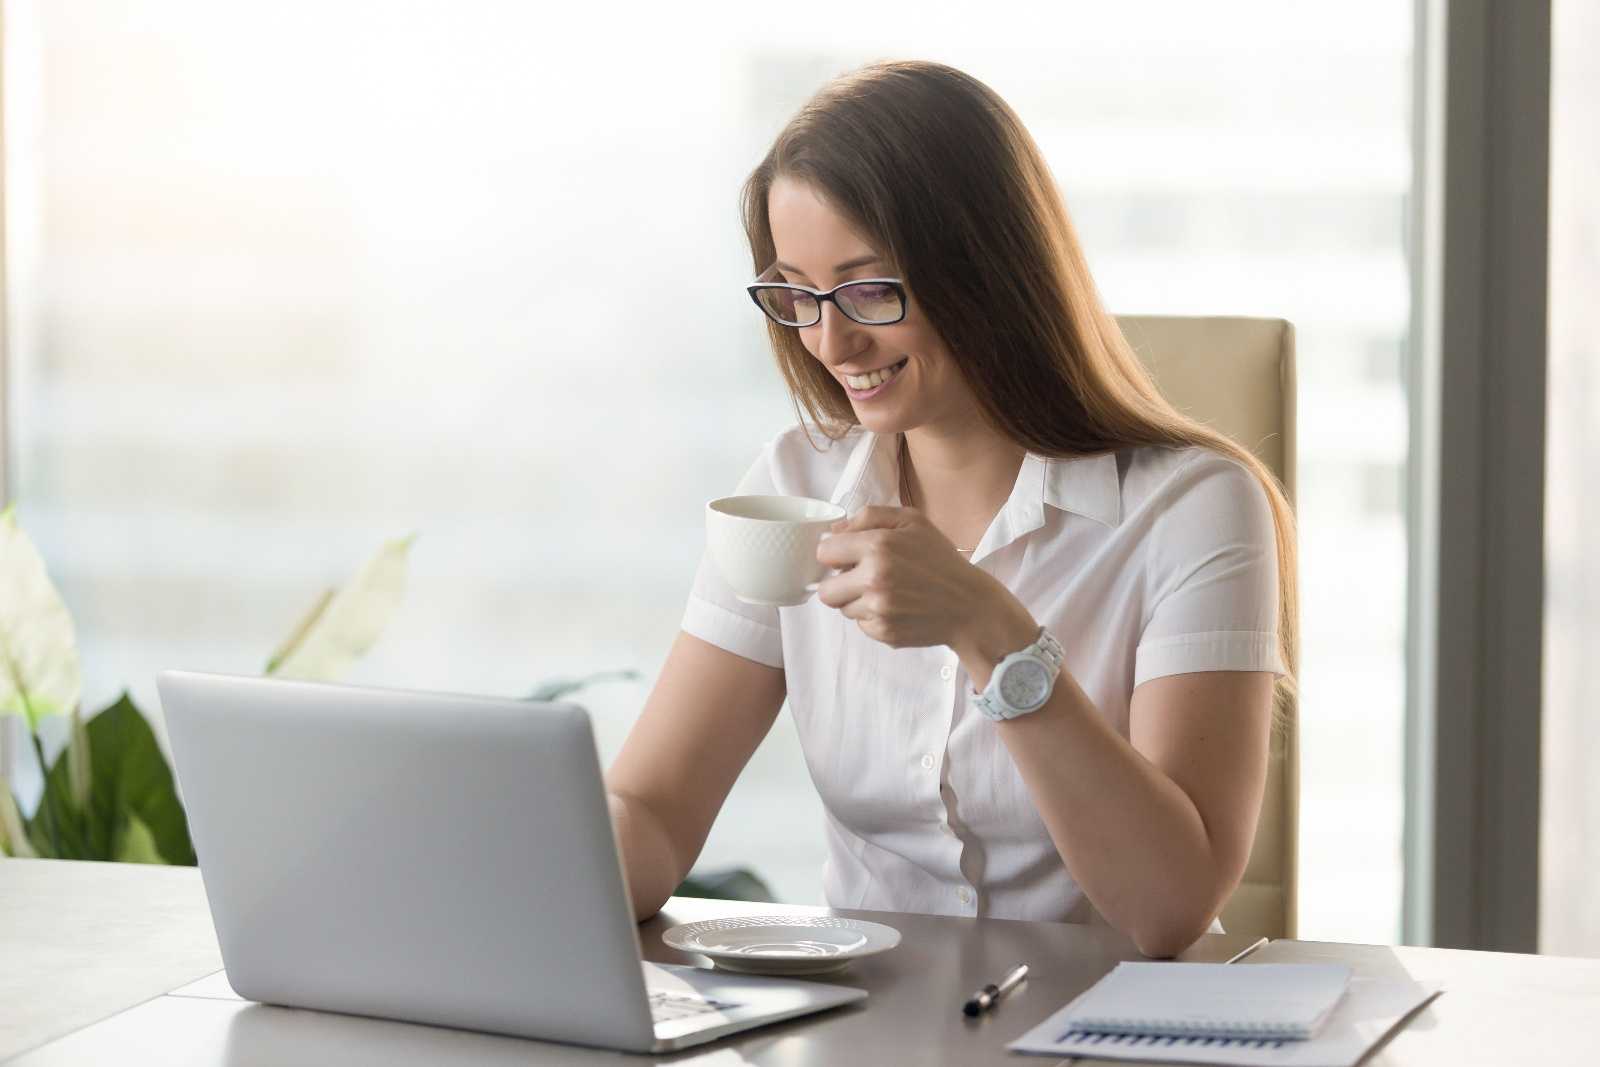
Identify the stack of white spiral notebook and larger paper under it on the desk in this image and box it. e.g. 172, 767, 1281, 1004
1006, 963, 1438, 1067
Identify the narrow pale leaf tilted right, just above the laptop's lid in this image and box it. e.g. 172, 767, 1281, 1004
267, 534, 416, 681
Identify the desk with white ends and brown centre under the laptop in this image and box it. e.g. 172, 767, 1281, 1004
0, 859, 1600, 1067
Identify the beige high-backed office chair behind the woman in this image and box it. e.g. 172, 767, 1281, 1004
1117, 315, 1299, 937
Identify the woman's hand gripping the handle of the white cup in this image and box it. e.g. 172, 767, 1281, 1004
816, 506, 1010, 648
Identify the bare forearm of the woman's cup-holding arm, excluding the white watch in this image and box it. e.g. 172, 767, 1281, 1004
952, 593, 1232, 957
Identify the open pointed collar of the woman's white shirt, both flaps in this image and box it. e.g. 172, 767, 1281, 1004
829, 430, 1122, 547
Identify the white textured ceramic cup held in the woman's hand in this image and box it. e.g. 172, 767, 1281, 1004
706, 496, 845, 606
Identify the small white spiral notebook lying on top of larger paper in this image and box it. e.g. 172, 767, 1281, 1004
1067, 963, 1350, 1038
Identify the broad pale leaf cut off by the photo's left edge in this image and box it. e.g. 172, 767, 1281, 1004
0, 507, 83, 733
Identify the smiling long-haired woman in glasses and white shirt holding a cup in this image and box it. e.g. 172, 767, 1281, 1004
606, 62, 1294, 957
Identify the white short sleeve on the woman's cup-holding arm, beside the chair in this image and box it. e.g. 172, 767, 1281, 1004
1133, 450, 1285, 686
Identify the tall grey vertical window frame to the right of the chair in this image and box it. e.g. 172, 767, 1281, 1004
1402, 0, 1550, 952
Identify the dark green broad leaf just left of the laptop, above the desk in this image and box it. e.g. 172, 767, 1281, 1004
27, 693, 195, 865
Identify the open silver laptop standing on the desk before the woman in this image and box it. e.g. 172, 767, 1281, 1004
157, 670, 867, 1053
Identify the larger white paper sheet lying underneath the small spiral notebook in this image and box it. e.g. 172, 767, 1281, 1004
1006, 963, 1442, 1067
